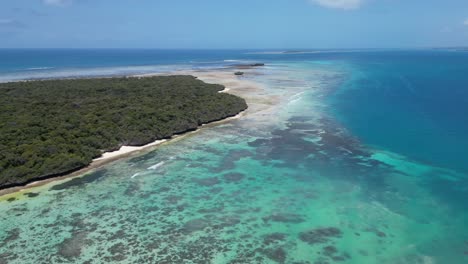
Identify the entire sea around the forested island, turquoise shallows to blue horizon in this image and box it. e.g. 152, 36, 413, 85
0, 49, 468, 264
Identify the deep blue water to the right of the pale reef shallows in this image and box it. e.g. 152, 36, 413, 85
331, 51, 468, 172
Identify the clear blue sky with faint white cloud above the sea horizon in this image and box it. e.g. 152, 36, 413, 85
0, 0, 468, 49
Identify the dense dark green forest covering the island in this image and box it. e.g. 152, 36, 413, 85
0, 76, 247, 188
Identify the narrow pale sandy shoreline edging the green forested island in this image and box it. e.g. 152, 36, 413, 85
0, 70, 259, 198
